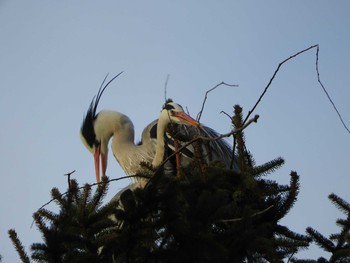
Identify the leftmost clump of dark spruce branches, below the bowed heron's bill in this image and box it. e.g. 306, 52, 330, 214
10, 178, 121, 262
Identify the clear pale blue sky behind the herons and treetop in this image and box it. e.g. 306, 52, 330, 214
0, 0, 350, 262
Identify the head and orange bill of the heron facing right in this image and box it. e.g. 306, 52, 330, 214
161, 99, 200, 127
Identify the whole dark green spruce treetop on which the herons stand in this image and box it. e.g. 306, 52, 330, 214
8, 106, 309, 263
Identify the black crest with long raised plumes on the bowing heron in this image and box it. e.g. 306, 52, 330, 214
80, 72, 123, 147
